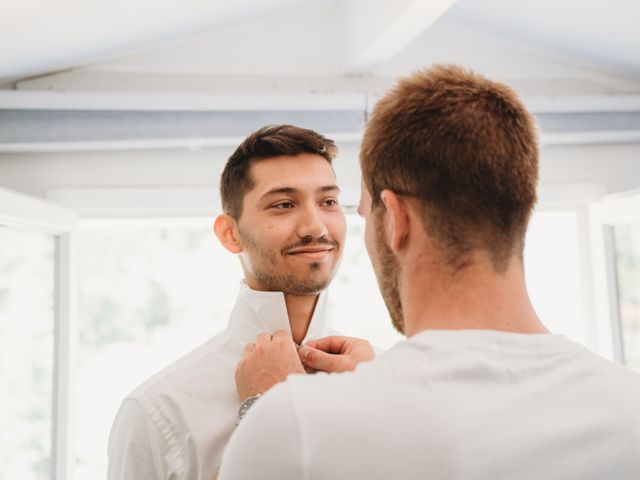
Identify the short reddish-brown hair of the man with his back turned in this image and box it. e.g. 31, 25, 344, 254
360, 65, 538, 271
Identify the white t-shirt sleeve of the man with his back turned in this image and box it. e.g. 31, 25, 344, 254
218, 382, 305, 480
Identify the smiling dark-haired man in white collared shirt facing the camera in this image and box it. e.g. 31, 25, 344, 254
108, 125, 362, 480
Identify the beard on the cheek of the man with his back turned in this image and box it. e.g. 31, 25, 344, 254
371, 217, 405, 335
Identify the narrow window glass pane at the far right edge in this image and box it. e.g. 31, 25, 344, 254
613, 223, 640, 371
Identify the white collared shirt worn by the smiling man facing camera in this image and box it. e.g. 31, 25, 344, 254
107, 284, 332, 480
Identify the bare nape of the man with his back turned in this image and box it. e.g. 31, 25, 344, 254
399, 255, 548, 336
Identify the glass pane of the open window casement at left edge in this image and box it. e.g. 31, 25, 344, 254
0, 226, 55, 480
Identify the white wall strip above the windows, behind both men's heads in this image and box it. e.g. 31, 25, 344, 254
0, 143, 640, 206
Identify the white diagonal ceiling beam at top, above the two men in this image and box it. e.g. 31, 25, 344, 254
345, 0, 457, 74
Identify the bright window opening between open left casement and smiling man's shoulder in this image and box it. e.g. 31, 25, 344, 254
76, 220, 241, 478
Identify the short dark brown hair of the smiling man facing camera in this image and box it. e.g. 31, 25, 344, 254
220, 125, 338, 219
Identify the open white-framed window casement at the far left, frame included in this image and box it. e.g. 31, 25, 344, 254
0, 188, 75, 480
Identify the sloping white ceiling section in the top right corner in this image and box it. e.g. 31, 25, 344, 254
447, 0, 640, 78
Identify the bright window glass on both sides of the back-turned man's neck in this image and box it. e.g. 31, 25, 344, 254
330, 211, 586, 348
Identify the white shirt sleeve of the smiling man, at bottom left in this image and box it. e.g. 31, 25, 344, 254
107, 398, 180, 480
